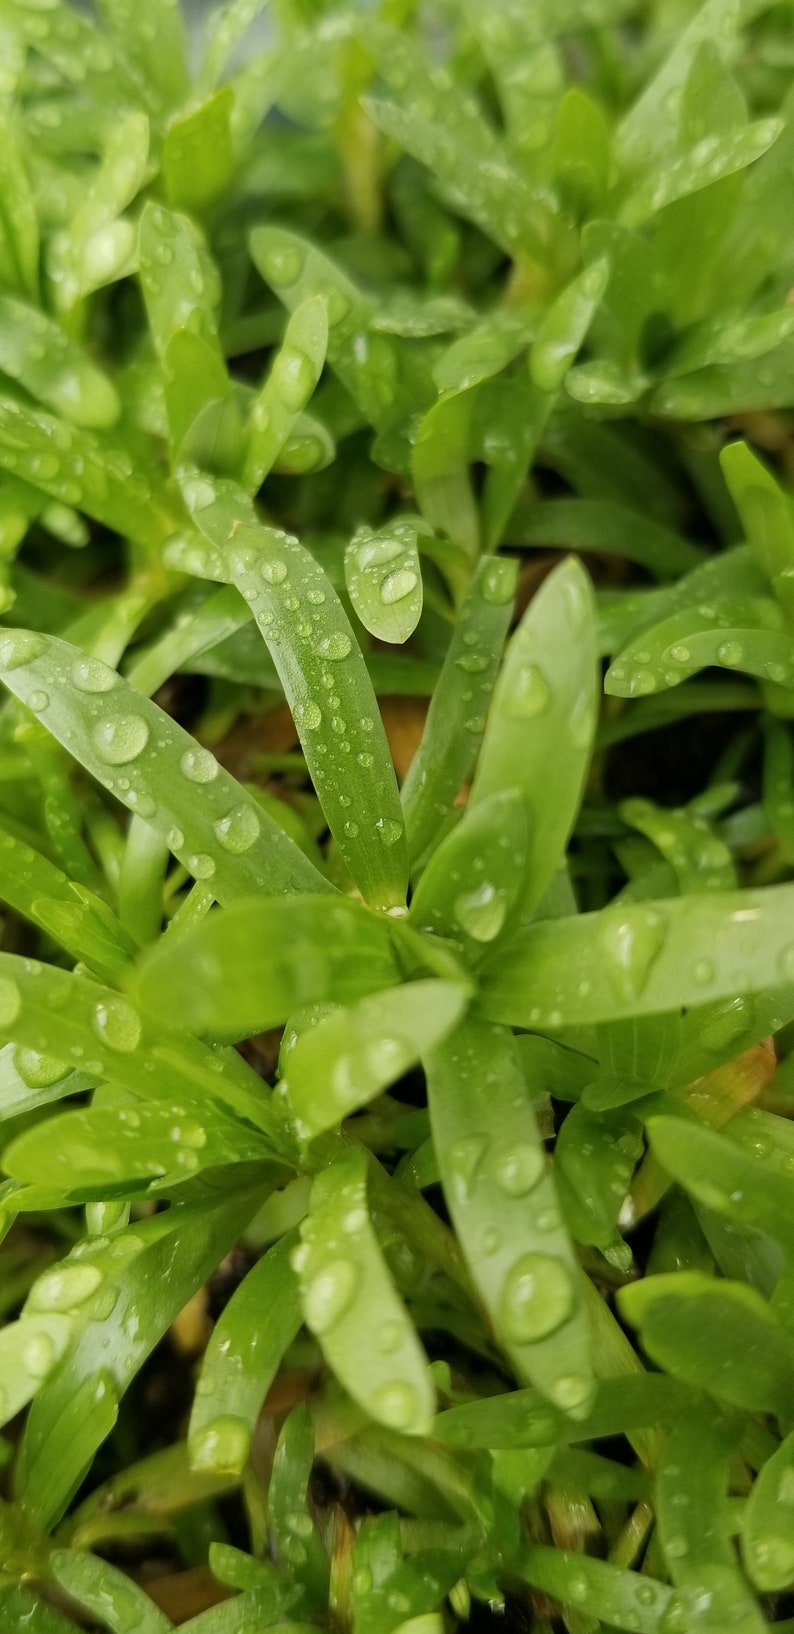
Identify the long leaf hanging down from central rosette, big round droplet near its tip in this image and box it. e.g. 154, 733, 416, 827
426, 1021, 593, 1417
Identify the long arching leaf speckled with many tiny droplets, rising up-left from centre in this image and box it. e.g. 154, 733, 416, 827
181, 472, 408, 909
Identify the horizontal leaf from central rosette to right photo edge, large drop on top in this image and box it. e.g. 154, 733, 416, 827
480, 886, 794, 1029
